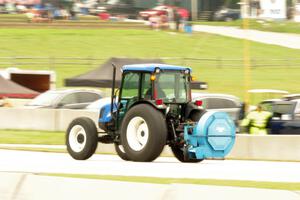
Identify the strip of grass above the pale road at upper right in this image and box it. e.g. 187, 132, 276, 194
193, 20, 300, 34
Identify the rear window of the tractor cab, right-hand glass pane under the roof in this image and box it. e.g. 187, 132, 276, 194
155, 71, 189, 103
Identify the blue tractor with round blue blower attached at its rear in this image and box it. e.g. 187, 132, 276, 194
66, 64, 235, 162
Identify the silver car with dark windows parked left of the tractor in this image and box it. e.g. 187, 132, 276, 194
26, 89, 102, 109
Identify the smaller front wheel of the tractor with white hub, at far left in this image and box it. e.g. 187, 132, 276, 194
66, 117, 98, 160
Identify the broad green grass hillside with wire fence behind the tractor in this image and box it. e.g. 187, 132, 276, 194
0, 29, 300, 100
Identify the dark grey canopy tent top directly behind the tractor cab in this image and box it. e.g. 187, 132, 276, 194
65, 58, 164, 88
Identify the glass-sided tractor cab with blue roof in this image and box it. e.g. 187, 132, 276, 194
115, 64, 191, 125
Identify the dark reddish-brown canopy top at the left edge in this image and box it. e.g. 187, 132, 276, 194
0, 76, 39, 99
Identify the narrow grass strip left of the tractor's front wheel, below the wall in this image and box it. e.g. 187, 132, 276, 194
0, 130, 65, 145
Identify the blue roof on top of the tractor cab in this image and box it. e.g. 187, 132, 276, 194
122, 63, 192, 72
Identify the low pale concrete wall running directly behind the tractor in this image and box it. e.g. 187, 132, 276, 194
0, 108, 300, 161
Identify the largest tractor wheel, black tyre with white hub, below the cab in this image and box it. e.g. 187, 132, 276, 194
121, 104, 168, 162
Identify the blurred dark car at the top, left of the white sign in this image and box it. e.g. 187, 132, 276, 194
213, 8, 241, 22
